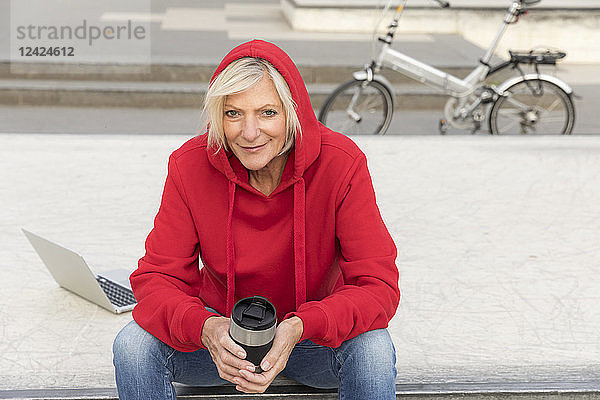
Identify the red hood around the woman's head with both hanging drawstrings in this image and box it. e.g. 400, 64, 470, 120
207, 40, 323, 316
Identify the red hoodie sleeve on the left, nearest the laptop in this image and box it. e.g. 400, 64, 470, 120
130, 155, 216, 351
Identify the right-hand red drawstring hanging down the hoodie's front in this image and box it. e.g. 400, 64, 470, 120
294, 177, 306, 310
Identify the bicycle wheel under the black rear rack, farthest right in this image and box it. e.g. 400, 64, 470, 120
489, 79, 575, 135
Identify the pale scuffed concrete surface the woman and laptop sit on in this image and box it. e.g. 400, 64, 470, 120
0, 134, 600, 390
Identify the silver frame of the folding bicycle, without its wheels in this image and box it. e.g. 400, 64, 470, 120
373, 0, 523, 97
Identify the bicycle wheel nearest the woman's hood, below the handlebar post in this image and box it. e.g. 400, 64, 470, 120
319, 79, 394, 135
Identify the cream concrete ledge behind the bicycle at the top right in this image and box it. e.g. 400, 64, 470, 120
281, 0, 600, 63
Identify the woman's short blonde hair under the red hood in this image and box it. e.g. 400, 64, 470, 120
203, 57, 302, 155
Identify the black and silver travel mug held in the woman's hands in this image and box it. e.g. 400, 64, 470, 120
229, 296, 277, 373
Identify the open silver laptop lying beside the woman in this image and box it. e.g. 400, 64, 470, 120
21, 229, 136, 314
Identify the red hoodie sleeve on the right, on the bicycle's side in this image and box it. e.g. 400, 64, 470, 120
290, 154, 400, 347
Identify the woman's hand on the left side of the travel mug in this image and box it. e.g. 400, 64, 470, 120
201, 317, 255, 384
